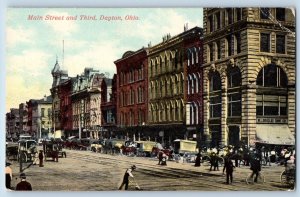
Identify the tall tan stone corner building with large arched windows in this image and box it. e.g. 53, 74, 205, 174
203, 8, 296, 147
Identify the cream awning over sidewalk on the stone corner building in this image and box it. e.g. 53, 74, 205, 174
256, 124, 295, 145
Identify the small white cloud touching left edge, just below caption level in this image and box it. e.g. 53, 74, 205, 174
6, 26, 35, 48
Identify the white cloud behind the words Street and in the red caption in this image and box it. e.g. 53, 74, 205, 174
44, 10, 78, 36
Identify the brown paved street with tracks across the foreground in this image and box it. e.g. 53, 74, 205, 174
8, 150, 294, 191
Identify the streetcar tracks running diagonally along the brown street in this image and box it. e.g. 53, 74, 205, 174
64, 152, 284, 191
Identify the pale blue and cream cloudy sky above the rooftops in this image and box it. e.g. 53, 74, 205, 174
5, 7, 203, 112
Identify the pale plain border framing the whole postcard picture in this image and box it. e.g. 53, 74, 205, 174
0, 0, 300, 197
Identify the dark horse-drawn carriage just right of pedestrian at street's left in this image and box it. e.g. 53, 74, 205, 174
43, 141, 67, 160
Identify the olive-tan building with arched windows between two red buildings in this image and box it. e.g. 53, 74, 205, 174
148, 27, 202, 144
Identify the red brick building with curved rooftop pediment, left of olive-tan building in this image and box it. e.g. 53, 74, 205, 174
115, 48, 148, 137
